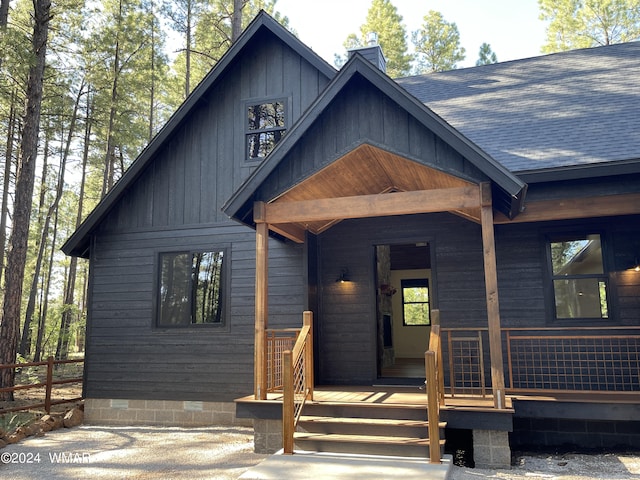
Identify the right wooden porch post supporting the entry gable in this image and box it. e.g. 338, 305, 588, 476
480, 183, 505, 408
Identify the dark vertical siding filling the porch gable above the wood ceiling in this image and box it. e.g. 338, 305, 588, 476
256, 76, 488, 201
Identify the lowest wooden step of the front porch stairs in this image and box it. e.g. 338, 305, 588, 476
294, 432, 444, 458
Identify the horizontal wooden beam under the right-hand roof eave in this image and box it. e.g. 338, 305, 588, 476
494, 193, 640, 224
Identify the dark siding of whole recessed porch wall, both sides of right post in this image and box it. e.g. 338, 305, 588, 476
317, 213, 640, 384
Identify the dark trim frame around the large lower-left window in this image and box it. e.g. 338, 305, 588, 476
152, 245, 231, 332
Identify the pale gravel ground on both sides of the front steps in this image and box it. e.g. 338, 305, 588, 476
0, 426, 640, 480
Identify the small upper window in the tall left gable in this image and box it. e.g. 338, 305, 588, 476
246, 100, 286, 160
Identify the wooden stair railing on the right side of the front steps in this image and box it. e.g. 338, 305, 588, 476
424, 316, 444, 463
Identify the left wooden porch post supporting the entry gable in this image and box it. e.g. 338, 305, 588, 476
253, 202, 269, 400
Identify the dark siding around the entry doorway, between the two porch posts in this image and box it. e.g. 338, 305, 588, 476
317, 214, 487, 384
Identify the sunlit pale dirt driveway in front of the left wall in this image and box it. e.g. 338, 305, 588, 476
0, 425, 266, 480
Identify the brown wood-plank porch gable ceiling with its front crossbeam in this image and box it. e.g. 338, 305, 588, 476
265, 144, 480, 241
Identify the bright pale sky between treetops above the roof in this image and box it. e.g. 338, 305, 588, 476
276, 0, 545, 67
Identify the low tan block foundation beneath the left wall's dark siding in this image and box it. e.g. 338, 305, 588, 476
84, 398, 253, 427
